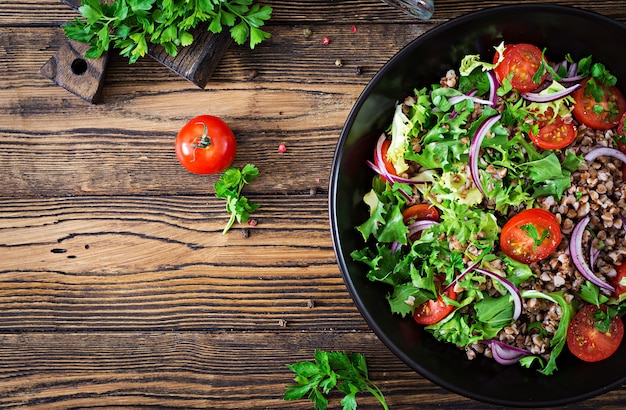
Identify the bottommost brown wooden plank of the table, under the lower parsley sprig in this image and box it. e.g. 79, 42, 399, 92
0, 331, 624, 410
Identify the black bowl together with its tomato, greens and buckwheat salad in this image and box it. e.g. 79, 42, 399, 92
330, 5, 626, 406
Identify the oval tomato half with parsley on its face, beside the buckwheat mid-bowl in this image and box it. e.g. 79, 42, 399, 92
500, 208, 561, 263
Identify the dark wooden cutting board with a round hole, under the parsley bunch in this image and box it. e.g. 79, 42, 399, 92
40, 0, 232, 104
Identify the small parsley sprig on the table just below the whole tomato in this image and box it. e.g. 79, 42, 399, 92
213, 164, 259, 234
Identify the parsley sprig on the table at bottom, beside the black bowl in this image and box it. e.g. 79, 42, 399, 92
284, 350, 388, 410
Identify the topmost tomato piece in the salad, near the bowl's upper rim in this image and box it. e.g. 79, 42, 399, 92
493, 43, 548, 92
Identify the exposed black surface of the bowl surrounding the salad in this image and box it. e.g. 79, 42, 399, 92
329, 5, 626, 407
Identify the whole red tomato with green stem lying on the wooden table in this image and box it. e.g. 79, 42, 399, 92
174, 115, 237, 174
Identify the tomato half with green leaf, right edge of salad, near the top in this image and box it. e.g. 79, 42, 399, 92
572, 78, 626, 130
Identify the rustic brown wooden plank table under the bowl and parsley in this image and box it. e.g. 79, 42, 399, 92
0, 0, 626, 409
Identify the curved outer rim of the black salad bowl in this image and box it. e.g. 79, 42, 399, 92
328, 3, 626, 407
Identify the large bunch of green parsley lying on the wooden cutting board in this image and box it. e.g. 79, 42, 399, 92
63, 0, 272, 64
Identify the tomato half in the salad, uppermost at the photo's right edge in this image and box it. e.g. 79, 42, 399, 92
572, 78, 626, 132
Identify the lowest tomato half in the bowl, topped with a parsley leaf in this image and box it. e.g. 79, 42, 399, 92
567, 305, 624, 362
